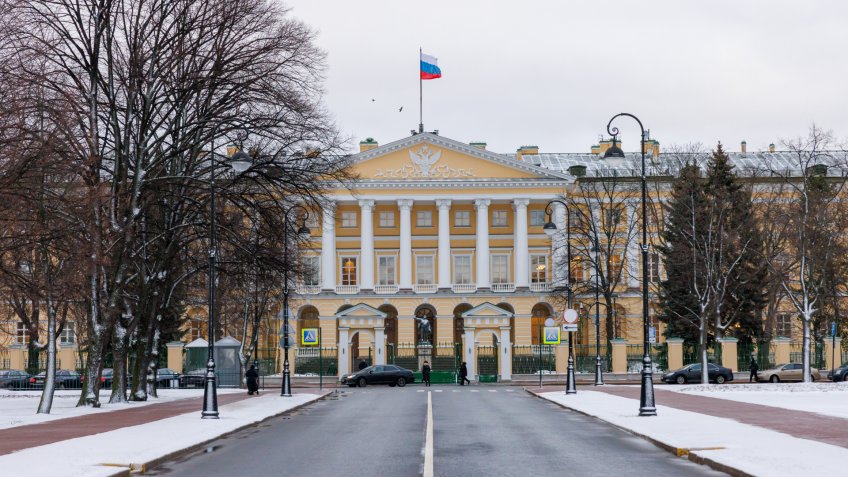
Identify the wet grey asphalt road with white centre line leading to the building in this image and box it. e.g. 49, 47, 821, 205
153, 386, 723, 477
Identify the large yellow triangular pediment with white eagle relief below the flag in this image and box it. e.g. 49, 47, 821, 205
353, 133, 571, 181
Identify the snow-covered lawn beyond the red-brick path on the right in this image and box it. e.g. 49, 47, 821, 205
662, 382, 848, 419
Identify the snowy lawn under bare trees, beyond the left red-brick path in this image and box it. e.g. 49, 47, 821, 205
0, 389, 244, 429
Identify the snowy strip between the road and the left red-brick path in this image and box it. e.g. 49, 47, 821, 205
0, 393, 320, 477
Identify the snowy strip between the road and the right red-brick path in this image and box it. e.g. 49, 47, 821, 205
541, 390, 848, 477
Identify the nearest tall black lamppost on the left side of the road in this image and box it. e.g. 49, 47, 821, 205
200, 145, 253, 419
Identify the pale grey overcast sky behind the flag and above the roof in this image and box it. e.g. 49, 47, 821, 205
285, 0, 848, 153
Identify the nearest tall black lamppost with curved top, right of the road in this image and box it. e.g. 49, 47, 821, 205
604, 113, 657, 416
